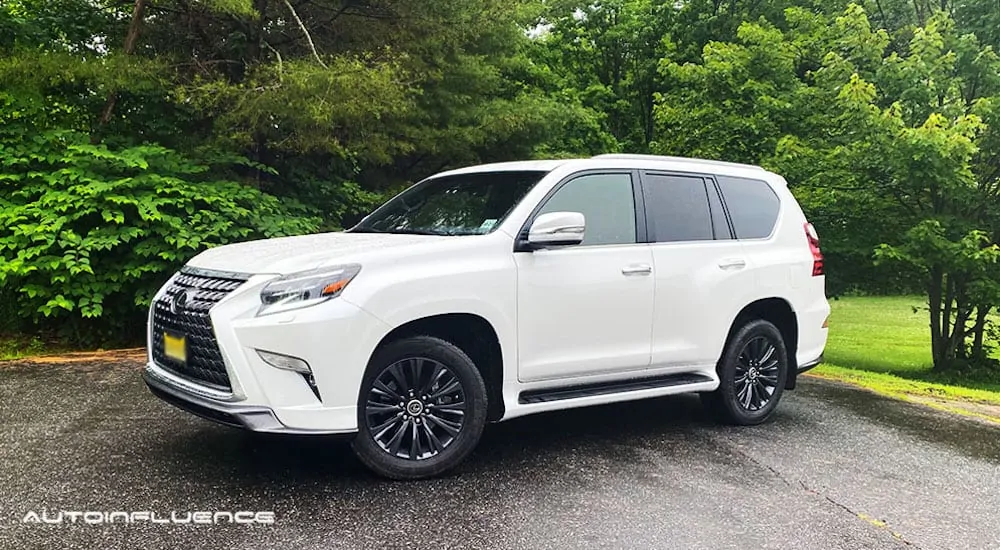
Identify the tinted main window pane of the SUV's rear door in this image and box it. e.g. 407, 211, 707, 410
643, 174, 714, 243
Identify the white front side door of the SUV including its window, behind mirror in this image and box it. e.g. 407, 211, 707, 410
515, 172, 654, 381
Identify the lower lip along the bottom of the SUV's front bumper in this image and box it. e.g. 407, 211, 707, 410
142, 365, 354, 435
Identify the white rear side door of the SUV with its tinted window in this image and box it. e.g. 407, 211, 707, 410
641, 171, 756, 370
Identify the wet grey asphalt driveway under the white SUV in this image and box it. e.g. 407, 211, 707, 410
0, 360, 1000, 550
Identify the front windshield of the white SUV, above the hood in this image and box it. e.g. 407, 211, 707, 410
351, 171, 546, 235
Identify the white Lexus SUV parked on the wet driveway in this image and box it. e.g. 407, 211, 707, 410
144, 155, 830, 479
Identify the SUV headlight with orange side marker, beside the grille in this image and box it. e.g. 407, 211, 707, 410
257, 264, 361, 317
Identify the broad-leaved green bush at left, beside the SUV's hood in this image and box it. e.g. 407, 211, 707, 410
0, 122, 319, 343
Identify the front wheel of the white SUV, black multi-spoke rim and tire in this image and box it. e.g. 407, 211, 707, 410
351, 336, 487, 480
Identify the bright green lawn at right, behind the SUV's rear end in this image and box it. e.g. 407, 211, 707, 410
812, 296, 1000, 405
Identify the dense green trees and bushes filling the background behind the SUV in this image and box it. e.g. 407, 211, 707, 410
0, 0, 1000, 362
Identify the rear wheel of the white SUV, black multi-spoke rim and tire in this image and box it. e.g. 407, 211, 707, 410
702, 319, 789, 426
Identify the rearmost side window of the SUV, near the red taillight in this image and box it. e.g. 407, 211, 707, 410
716, 176, 781, 239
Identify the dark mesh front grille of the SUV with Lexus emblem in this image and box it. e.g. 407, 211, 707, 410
152, 268, 248, 391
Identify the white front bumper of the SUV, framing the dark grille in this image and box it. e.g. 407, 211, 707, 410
144, 275, 388, 434
